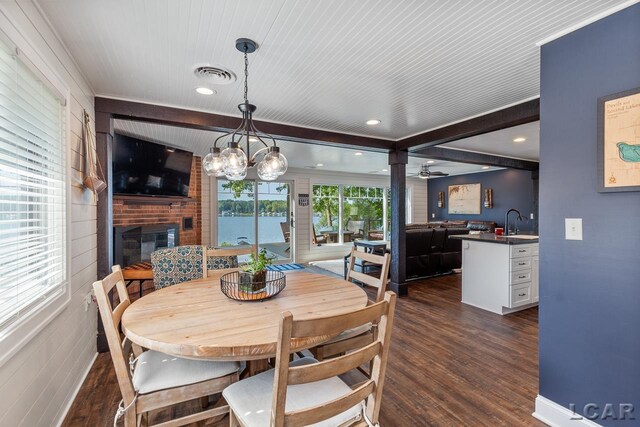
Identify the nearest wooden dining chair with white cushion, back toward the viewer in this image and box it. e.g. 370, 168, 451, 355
222, 292, 396, 427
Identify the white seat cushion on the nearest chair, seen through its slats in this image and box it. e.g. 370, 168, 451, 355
222, 357, 363, 427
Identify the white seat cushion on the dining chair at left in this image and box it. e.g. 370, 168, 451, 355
132, 350, 240, 394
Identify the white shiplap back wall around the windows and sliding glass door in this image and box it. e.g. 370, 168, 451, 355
202, 169, 427, 263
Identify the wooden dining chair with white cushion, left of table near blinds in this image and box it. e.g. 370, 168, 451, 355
93, 265, 240, 427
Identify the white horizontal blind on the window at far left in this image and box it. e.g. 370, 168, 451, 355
0, 37, 67, 337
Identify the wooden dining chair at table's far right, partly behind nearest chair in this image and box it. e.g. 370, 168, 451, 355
310, 246, 391, 360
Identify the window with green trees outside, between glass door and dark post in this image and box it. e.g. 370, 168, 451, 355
312, 185, 387, 244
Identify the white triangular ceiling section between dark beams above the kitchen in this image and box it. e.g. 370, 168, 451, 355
440, 122, 540, 161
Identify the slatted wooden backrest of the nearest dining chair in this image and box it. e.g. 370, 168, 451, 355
271, 292, 396, 427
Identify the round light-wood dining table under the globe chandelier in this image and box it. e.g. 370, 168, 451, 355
122, 271, 367, 370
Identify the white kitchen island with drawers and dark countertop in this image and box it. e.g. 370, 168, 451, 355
450, 233, 539, 315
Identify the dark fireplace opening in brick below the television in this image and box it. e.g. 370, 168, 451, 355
113, 224, 180, 268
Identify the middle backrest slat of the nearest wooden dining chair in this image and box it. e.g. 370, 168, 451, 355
288, 341, 381, 385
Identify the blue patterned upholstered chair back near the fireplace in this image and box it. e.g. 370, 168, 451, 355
151, 245, 204, 289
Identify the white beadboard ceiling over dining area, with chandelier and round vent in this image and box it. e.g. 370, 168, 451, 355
39, 0, 624, 140
